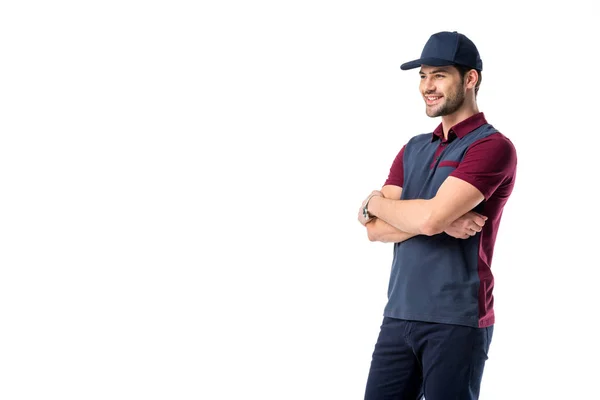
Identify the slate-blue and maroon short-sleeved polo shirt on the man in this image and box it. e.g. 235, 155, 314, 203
384, 113, 517, 327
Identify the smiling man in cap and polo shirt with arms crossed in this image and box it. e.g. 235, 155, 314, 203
359, 32, 517, 400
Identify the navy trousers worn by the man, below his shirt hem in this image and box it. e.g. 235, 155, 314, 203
365, 317, 493, 400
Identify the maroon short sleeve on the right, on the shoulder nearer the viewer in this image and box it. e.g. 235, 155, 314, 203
450, 133, 517, 200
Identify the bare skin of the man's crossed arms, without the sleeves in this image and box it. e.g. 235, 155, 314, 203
359, 177, 487, 242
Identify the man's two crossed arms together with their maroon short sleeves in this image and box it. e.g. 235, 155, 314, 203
359, 133, 517, 242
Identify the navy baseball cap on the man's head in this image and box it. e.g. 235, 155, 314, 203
400, 31, 483, 71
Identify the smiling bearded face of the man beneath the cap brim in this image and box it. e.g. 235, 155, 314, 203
419, 65, 465, 118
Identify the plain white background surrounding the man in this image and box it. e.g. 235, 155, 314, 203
0, 0, 600, 400
